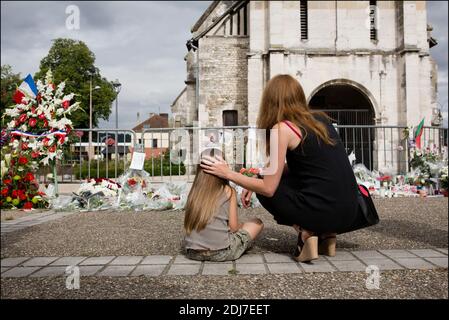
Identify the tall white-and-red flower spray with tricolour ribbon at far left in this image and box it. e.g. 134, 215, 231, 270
2, 70, 79, 199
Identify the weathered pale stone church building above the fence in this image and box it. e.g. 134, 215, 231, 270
171, 1, 437, 172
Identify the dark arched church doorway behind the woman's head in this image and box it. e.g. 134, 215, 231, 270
309, 79, 375, 170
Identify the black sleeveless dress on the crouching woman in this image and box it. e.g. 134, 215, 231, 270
257, 117, 363, 233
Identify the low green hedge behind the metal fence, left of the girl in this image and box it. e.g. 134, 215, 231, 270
73, 159, 186, 180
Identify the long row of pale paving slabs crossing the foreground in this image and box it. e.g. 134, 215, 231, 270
1, 248, 448, 278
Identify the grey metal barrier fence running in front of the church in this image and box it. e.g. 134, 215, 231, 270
21, 125, 448, 183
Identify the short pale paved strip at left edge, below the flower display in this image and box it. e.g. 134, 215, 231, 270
1, 210, 77, 234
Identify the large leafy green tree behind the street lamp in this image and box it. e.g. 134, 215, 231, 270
34, 38, 116, 128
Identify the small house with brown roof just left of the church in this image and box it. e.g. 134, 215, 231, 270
133, 113, 169, 159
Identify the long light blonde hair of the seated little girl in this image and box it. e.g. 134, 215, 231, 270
184, 159, 229, 234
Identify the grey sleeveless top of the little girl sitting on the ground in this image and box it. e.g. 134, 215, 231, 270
185, 192, 230, 250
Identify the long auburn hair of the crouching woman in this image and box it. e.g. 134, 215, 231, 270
257, 74, 335, 151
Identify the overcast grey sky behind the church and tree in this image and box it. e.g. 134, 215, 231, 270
1, 1, 448, 128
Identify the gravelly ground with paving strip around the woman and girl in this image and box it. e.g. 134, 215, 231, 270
1, 198, 448, 299
